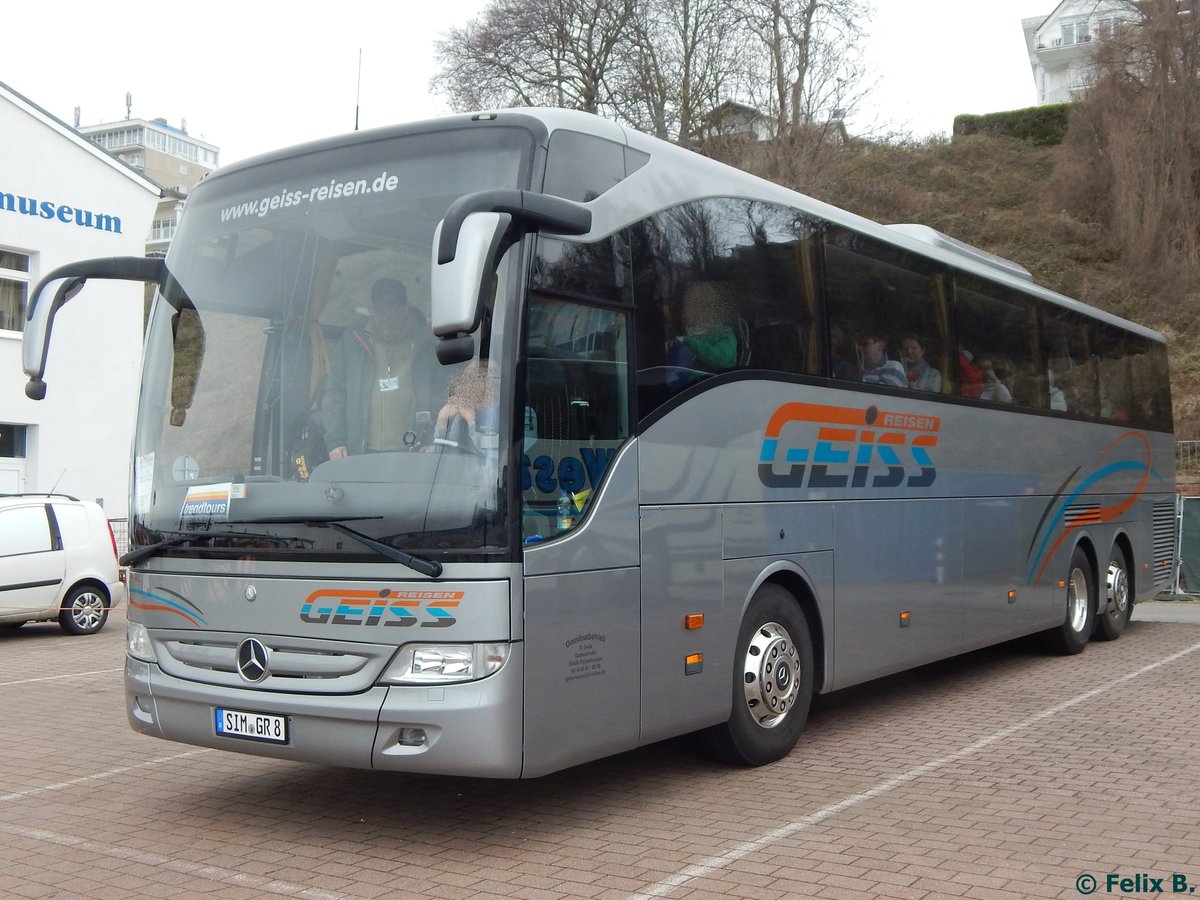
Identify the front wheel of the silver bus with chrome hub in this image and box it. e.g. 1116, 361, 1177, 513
708, 583, 814, 766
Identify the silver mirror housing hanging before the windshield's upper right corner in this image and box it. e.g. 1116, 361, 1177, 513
430, 212, 512, 365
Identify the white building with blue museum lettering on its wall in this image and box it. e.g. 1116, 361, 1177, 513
0, 84, 161, 518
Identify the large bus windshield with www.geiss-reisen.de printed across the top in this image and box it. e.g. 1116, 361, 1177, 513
132, 128, 532, 559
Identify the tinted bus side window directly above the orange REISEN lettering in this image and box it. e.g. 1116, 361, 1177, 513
824, 228, 955, 394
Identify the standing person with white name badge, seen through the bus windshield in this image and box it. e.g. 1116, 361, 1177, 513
322, 278, 439, 460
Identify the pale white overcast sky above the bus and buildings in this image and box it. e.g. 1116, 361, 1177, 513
0, 0, 1041, 164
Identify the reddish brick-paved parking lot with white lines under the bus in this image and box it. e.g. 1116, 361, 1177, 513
0, 604, 1200, 900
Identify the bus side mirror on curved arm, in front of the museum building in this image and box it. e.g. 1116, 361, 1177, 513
20, 257, 166, 400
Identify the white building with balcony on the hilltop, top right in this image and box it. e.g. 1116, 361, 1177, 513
1021, 0, 1136, 104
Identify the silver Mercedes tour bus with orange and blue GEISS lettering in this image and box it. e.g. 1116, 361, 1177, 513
24, 109, 1174, 778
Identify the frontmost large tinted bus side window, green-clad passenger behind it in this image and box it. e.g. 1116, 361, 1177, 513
630, 198, 821, 418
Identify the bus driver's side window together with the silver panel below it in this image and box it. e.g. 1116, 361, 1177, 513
521, 295, 641, 778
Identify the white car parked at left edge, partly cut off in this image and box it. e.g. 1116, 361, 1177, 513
0, 494, 125, 635
